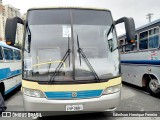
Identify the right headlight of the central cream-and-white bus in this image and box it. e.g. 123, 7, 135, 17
103, 84, 121, 95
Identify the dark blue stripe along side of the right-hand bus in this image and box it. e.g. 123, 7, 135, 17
121, 60, 160, 65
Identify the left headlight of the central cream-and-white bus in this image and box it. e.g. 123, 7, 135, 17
22, 88, 44, 98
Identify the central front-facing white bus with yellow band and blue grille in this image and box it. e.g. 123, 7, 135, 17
6, 1, 135, 114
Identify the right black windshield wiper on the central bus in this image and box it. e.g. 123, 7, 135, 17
77, 35, 100, 82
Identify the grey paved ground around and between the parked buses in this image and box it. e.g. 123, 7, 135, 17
0, 84, 160, 120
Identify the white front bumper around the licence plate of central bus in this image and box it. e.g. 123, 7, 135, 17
23, 91, 121, 114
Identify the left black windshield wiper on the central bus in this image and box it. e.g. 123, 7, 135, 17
48, 37, 71, 83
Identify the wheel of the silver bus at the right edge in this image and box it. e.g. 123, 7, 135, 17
147, 78, 160, 97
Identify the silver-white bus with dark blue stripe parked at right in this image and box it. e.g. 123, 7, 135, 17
119, 19, 160, 96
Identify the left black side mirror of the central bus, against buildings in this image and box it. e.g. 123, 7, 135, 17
5, 17, 24, 45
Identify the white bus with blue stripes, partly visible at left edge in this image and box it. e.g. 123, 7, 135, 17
0, 42, 22, 96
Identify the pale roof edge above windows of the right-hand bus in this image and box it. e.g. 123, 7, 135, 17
118, 19, 160, 38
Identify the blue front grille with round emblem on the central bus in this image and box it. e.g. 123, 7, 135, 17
45, 90, 103, 99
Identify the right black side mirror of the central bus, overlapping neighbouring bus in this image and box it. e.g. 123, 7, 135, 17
114, 17, 135, 43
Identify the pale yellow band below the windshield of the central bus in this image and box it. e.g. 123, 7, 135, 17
22, 77, 121, 92
